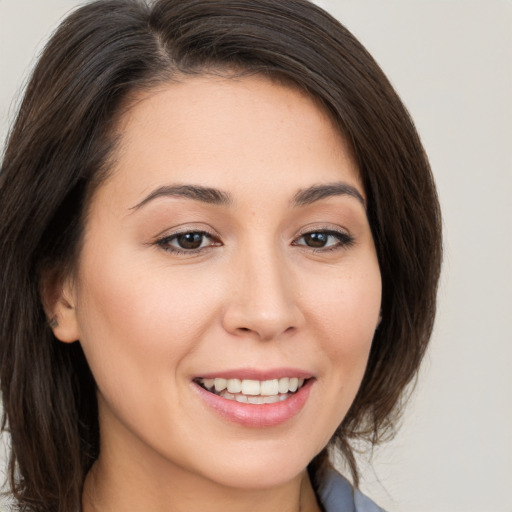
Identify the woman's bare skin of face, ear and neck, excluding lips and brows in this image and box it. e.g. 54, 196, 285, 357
53, 76, 381, 512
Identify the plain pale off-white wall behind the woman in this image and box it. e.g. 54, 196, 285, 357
0, 0, 512, 512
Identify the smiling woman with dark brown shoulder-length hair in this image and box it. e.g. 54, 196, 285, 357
0, 0, 441, 512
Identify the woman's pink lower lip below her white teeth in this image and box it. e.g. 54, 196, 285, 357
193, 379, 314, 428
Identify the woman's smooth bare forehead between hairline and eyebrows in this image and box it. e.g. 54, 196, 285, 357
98, 76, 361, 206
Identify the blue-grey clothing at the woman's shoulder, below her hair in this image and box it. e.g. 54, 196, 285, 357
318, 470, 384, 512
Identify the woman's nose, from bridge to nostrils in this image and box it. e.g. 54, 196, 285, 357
223, 247, 304, 340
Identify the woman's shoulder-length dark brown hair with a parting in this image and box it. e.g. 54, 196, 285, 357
0, 0, 441, 512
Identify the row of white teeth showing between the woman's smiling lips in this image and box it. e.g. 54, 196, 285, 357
194, 377, 309, 404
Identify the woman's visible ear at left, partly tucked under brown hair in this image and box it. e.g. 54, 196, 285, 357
41, 272, 80, 343
